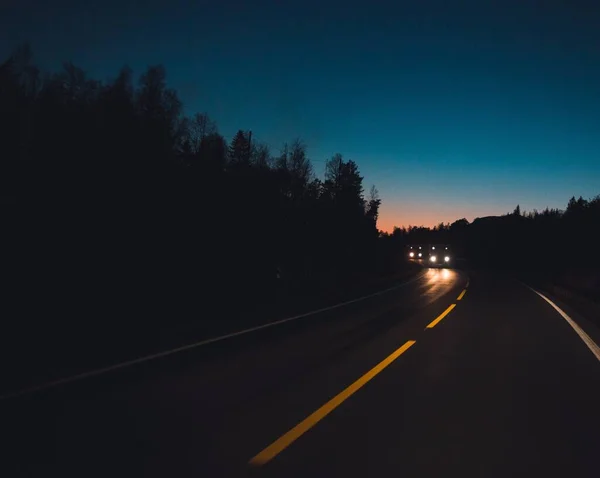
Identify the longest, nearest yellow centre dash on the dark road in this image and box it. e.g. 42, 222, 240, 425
250, 340, 416, 466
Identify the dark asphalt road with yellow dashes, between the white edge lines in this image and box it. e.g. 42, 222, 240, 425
0, 269, 600, 478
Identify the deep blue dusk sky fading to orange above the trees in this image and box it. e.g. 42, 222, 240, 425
0, 0, 600, 231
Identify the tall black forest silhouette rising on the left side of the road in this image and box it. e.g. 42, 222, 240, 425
0, 47, 381, 324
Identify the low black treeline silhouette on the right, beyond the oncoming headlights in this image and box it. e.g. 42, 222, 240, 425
384, 195, 600, 297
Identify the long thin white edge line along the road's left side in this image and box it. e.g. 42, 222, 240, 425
0, 272, 424, 400
